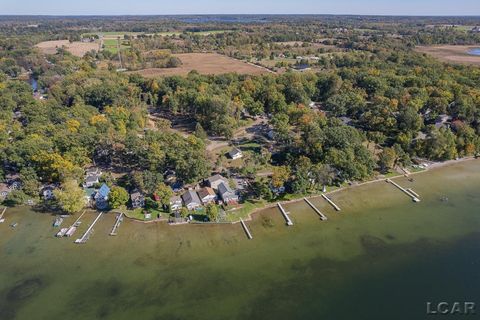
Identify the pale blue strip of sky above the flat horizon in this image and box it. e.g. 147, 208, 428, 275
0, 0, 480, 16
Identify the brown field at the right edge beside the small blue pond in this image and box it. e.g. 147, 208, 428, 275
415, 45, 480, 66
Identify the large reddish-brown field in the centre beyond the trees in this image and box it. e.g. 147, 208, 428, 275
131, 53, 269, 78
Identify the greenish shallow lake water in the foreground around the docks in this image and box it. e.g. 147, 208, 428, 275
0, 160, 480, 320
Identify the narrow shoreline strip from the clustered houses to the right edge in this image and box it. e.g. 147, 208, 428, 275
127, 156, 477, 226
